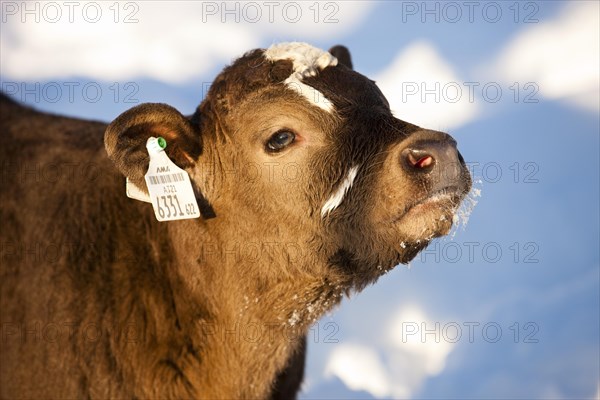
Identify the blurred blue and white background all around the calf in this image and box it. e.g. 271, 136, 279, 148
0, 1, 600, 399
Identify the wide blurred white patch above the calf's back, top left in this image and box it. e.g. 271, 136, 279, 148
1, 2, 259, 82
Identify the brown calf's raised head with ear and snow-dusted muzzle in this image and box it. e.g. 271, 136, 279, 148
105, 43, 471, 287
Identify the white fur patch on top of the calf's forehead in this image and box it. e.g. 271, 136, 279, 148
265, 42, 337, 112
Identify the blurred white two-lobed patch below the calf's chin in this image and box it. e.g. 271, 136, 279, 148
325, 307, 454, 398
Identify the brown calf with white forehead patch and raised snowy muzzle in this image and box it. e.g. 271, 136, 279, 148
0, 43, 470, 399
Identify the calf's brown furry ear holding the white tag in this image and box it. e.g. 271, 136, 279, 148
104, 103, 201, 191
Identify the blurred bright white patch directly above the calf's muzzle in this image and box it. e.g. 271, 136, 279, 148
375, 41, 478, 130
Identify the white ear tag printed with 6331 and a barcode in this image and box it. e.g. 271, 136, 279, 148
144, 137, 200, 221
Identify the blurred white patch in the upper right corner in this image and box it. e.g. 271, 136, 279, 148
488, 1, 600, 111
